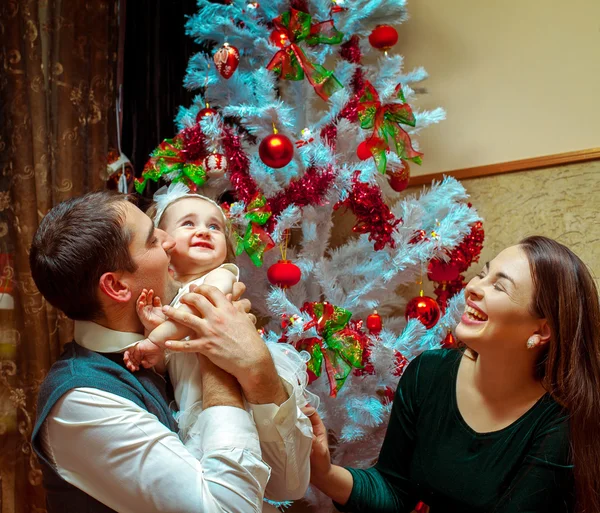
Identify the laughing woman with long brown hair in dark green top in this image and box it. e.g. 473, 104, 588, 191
311, 237, 600, 513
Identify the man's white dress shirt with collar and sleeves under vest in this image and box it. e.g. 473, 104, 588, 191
41, 321, 312, 513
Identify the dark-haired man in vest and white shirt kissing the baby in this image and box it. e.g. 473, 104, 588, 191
30, 192, 311, 513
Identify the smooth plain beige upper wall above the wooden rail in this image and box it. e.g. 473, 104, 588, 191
395, 0, 600, 175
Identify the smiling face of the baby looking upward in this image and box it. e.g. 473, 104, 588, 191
160, 198, 227, 279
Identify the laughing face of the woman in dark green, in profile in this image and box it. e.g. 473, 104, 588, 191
456, 246, 544, 353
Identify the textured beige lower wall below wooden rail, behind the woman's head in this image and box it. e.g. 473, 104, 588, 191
408, 161, 600, 302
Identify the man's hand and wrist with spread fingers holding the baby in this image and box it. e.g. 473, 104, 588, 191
164, 285, 287, 404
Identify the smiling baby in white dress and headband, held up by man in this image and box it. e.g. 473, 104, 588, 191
124, 183, 319, 511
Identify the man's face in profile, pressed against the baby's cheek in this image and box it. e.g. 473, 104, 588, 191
124, 203, 179, 305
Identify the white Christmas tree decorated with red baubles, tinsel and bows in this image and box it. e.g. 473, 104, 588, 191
137, 0, 480, 511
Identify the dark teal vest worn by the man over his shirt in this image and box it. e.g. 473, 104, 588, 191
32, 342, 177, 513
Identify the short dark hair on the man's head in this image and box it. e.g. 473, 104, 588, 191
29, 191, 137, 321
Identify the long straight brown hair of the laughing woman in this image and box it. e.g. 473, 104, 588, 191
520, 236, 600, 513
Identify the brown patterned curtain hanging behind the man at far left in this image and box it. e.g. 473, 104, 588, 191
0, 0, 119, 513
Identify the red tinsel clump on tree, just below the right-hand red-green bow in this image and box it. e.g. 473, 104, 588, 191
334, 171, 402, 251
